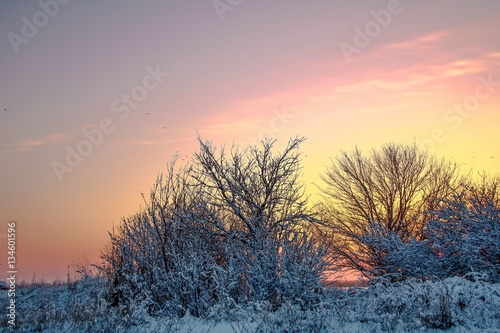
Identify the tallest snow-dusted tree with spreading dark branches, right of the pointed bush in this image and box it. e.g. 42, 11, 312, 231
192, 138, 325, 307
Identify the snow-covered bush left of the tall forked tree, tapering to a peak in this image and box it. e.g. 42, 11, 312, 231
97, 156, 227, 316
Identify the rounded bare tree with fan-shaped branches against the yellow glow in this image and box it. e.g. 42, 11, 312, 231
321, 143, 462, 277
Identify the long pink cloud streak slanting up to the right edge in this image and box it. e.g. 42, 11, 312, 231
189, 16, 500, 131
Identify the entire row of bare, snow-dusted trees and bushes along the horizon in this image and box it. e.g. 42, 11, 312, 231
96, 138, 500, 316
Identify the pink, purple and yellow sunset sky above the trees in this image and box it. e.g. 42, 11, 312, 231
0, 0, 500, 281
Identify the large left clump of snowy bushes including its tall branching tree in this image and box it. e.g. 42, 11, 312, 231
101, 139, 326, 317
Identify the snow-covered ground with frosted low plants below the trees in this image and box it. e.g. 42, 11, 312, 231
0, 278, 500, 333
